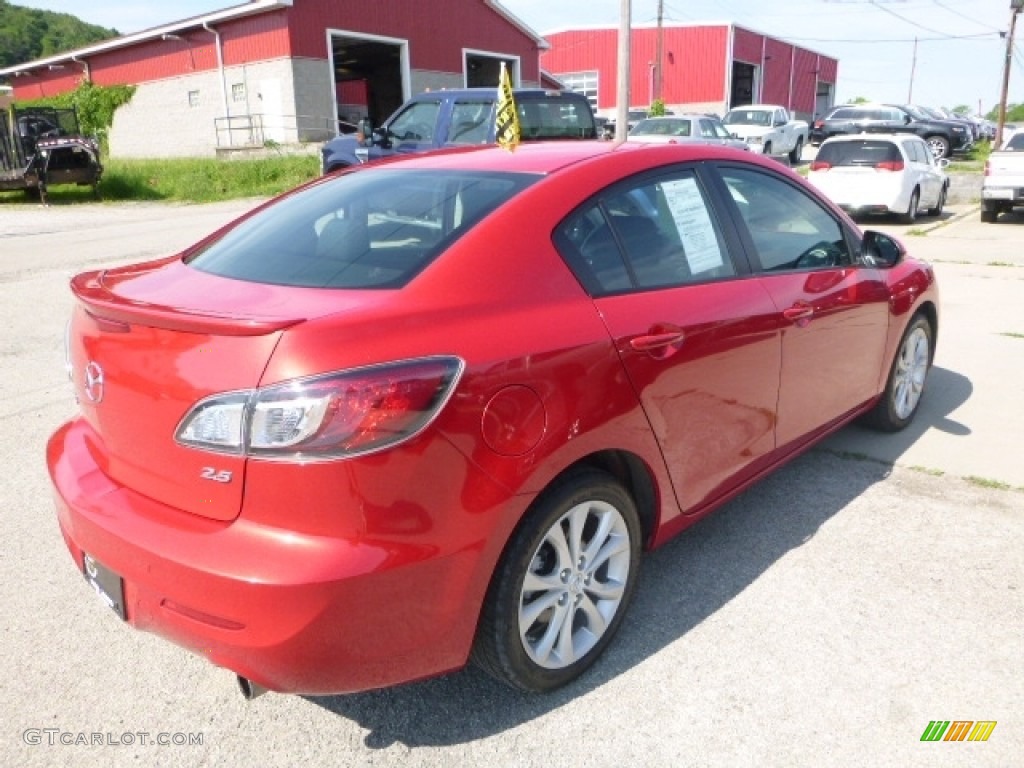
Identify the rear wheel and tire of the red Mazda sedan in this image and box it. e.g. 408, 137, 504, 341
472, 469, 641, 692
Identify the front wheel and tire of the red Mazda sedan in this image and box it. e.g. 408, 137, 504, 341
865, 314, 935, 432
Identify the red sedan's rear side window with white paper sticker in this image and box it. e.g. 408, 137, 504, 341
555, 171, 735, 296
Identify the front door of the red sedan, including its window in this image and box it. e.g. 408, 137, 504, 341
721, 165, 889, 446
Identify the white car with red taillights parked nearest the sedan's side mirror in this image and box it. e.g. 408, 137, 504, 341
807, 133, 949, 224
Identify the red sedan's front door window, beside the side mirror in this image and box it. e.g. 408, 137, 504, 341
722, 168, 853, 271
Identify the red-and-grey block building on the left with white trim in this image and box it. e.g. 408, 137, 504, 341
0, 0, 546, 157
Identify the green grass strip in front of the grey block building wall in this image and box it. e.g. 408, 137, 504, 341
0, 155, 319, 205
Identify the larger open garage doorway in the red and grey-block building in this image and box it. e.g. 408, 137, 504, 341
331, 33, 410, 133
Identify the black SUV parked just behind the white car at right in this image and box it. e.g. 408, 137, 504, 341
814, 104, 972, 159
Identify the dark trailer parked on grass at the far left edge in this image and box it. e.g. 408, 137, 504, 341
0, 89, 103, 205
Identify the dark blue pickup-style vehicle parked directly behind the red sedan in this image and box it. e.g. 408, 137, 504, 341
321, 88, 598, 173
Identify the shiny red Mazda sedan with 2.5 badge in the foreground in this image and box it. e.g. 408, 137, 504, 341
47, 142, 939, 695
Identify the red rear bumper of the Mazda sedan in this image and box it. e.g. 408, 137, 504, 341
47, 422, 522, 694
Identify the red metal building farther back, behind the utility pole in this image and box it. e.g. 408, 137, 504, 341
541, 24, 839, 120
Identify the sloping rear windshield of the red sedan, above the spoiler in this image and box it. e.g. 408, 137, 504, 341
187, 168, 539, 289
